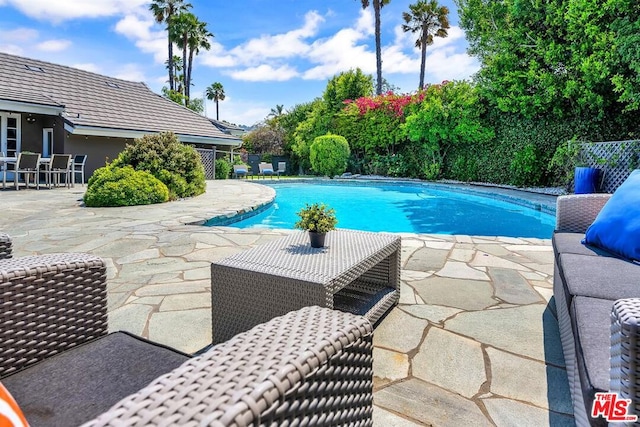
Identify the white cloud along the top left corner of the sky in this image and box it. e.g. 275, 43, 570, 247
2, 0, 148, 22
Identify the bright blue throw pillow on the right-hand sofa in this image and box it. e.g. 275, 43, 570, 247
584, 169, 640, 261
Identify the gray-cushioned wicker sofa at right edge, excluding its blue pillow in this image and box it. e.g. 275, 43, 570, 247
553, 194, 640, 426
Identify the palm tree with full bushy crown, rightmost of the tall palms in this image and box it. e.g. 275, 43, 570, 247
402, 0, 449, 89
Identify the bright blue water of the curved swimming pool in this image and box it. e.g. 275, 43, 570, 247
229, 183, 555, 238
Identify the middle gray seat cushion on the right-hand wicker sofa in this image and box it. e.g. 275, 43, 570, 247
559, 254, 640, 300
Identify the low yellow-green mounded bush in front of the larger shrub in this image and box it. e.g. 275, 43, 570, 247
84, 165, 169, 207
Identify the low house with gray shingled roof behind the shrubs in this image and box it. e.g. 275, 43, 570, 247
0, 53, 242, 181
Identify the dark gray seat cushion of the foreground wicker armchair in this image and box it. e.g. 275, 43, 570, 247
2, 332, 189, 427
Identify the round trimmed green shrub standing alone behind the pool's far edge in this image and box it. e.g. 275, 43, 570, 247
309, 135, 350, 178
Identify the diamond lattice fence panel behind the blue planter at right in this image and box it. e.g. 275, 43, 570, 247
581, 140, 640, 193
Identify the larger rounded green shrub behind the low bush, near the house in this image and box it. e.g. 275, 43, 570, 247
111, 132, 205, 200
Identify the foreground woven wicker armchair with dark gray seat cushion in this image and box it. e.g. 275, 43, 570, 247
0, 254, 373, 426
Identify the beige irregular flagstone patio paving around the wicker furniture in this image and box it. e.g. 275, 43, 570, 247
0, 180, 574, 426
